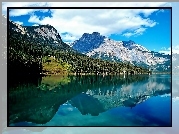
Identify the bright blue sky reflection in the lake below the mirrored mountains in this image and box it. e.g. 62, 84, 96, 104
42, 97, 170, 126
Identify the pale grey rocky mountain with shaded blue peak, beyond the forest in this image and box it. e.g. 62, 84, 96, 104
73, 32, 171, 71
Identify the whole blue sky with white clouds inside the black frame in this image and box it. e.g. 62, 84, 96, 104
2, 1, 175, 52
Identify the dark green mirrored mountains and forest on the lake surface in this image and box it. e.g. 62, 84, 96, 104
8, 75, 171, 124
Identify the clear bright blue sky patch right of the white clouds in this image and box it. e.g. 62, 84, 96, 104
110, 9, 171, 51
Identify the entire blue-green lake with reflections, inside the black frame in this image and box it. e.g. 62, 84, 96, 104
8, 74, 172, 126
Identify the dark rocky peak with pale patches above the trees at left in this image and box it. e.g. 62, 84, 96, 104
9, 20, 72, 51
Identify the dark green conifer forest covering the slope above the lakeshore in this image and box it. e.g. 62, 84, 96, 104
8, 24, 148, 75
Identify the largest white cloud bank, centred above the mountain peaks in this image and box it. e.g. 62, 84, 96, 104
28, 9, 156, 42
